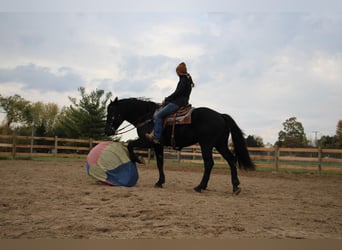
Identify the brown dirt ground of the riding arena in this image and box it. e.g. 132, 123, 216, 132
0, 160, 342, 239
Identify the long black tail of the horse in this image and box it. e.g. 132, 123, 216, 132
222, 114, 255, 170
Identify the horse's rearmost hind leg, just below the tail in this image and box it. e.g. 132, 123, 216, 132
216, 143, 241, 195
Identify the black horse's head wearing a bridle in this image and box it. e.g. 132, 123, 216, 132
105, 97, 125, 136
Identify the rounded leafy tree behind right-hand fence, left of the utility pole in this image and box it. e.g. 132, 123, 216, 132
276, 117, 308, 148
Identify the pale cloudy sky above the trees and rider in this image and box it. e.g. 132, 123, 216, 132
0, 0, 342, 144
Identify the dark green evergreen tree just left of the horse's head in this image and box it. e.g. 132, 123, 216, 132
55, 87, 112, 139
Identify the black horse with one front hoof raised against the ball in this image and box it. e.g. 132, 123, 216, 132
105, 98, 255, 194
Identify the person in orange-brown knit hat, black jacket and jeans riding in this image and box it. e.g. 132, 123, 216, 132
146, 62, 195, 144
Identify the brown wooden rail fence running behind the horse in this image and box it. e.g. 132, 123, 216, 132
0, 135, 342, 173
